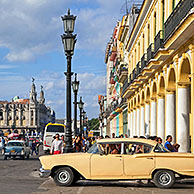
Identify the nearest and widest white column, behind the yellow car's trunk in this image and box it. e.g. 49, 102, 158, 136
177, 86, 190, 152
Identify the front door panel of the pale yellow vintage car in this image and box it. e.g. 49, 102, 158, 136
90, 142, 123, 179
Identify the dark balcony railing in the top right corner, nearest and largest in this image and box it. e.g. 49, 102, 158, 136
164, 0, 194, 41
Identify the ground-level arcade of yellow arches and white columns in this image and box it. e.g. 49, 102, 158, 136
128, 44, 194, 152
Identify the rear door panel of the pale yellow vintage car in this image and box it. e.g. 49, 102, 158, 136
123, 144, 155, 178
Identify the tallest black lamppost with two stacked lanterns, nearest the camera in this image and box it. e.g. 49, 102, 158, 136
61, 9, 76, 153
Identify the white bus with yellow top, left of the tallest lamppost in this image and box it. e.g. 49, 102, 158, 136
43, 123, 65, 152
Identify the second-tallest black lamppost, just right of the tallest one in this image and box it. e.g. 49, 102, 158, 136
72, 73, 79, 136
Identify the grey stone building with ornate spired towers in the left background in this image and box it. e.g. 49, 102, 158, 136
0, 79, 55, 133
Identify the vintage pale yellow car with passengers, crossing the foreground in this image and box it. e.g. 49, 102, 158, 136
40, 138, 194, 188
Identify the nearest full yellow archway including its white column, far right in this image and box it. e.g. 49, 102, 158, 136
177, 58, 191, 152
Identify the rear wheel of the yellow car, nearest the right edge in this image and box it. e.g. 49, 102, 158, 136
153, 170, 175, 189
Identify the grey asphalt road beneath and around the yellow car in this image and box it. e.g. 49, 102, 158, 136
0, 148, 194, 194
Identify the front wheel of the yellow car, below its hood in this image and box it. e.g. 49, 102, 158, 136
53, 167, 74, 186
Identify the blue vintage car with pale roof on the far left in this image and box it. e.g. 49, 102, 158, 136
2, 140, 30, 160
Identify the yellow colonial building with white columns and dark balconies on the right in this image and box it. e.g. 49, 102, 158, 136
104, 0, 194, 152
